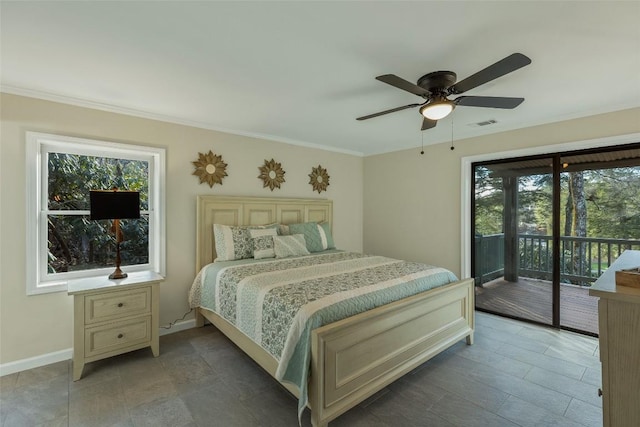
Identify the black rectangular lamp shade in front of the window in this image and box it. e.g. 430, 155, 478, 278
89, 190, 140, 220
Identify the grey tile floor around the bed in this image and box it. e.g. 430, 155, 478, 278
0, 313, 602, 427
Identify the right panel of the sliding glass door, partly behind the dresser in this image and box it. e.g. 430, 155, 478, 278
560, 149, 640, 333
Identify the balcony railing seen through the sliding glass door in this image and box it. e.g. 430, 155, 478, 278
475, 234, 640, 286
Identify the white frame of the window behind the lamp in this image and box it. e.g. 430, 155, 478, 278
26, 132, 166, 295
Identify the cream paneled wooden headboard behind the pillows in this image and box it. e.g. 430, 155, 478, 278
196, 196, 333, 274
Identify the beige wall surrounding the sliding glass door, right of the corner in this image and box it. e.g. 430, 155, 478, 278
363, 108, 640, 275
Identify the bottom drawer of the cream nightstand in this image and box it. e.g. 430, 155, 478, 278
84, 316, 151, 357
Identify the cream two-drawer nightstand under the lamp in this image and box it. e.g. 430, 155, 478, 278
67, 271, 164, 381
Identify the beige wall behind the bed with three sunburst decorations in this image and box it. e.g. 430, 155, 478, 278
0, 94, 363, 364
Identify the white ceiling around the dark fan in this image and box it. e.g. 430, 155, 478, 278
0, 1, 640, 155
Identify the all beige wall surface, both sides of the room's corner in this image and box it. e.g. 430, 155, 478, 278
0, 94, 640, 364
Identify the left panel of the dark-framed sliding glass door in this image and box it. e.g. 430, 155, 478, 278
474, 157, 554, 325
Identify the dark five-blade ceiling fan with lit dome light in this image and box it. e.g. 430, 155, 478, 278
356, 53, 531, 130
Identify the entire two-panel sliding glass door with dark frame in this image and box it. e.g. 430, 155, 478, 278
472, 144, 640, 335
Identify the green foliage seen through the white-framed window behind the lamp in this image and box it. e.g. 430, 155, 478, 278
47, 153, 149, 273
